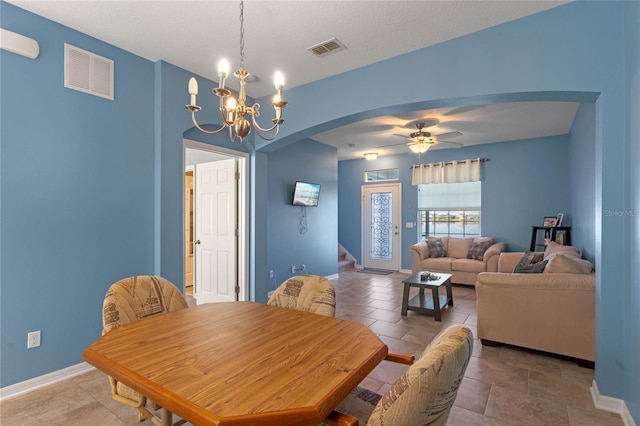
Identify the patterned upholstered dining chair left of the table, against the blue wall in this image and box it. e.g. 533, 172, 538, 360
102, 275, 187, 425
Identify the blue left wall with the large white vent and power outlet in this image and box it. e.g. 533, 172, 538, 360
0, 3, 154, 386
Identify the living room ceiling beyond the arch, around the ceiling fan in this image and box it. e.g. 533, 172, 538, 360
313, 102, 579, 160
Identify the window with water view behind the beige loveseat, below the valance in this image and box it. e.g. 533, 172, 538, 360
418, 181, 481, 240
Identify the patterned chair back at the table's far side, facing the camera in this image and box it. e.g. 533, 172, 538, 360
267, 275, 336, 317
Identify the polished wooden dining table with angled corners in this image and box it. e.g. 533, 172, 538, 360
83, 302, 388, 425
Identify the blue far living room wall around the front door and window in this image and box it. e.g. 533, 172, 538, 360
338, 136, 571, 269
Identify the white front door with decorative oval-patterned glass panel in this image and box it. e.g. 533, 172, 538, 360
362, 184, 402, 271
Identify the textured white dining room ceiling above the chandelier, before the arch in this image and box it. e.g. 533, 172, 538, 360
8, 0, 567, 98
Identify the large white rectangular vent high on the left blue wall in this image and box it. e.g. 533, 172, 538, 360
64, 43, 113, 100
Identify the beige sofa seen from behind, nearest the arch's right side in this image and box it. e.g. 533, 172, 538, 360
476, 242, 595, 366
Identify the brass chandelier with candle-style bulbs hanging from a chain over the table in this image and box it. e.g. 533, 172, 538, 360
186, 0, 287, 142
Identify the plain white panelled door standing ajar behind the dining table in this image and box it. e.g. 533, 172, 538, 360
194, 159, 238, 304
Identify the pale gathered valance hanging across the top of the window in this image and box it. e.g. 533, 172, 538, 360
411, 158, 482, 185
